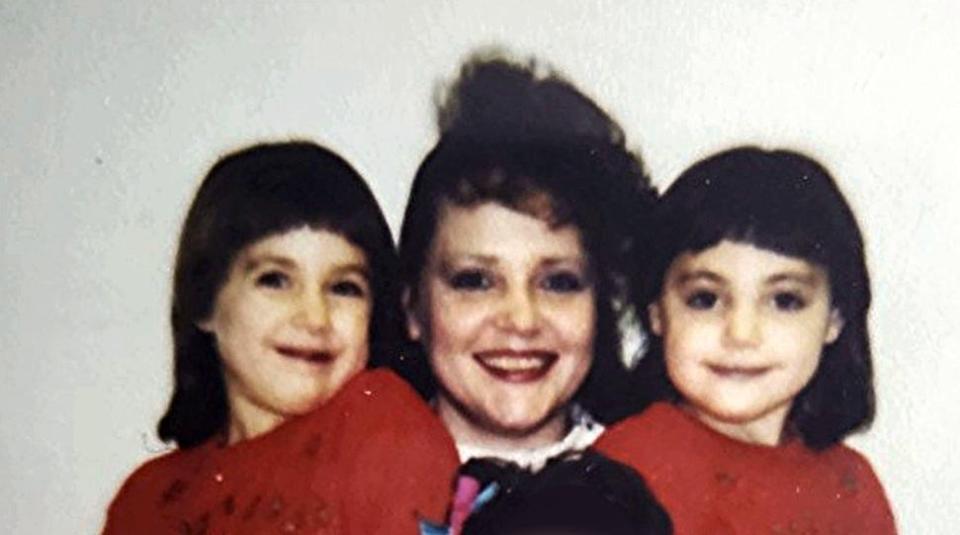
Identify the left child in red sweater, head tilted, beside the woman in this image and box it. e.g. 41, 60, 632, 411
104, 142, 457, 534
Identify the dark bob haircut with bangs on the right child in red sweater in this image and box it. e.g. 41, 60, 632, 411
637, 147, 874, 449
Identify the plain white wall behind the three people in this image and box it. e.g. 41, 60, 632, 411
0, 0, 960, 534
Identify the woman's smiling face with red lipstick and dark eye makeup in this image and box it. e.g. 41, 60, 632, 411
409, 202, 596, 435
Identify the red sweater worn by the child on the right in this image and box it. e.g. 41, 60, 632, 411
596, 403, 896, 535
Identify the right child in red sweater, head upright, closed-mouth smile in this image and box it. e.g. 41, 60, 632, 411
597, 148, 895, 535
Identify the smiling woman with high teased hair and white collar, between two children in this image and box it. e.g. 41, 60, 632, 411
400, 59, 653, 469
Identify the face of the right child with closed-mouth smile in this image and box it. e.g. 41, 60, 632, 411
649, 241, 843, 445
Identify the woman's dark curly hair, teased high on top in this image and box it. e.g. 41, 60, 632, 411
396, 54, 654, 421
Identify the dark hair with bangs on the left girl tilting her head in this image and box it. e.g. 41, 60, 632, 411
158, 141, 402, 448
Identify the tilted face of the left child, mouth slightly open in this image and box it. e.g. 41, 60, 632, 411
200, 227, 373, 436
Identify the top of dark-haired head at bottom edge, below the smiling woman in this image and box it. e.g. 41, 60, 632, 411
461, 450, 673, 535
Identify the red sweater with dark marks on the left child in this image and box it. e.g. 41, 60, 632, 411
104, 371, 459, 535
